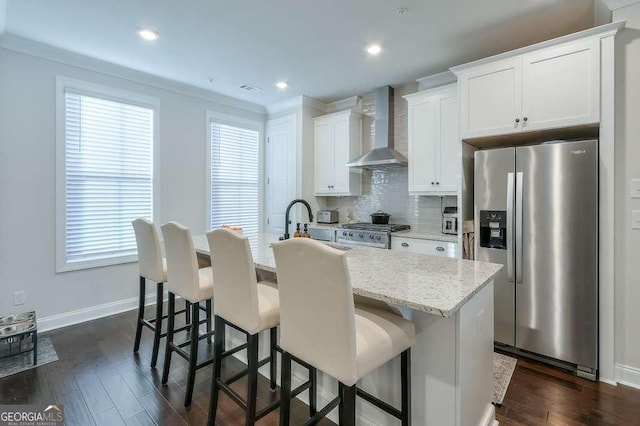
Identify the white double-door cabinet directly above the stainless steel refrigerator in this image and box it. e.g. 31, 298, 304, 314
456, 38, 600, 139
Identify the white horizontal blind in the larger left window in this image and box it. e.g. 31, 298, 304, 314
64, 90, 154, 263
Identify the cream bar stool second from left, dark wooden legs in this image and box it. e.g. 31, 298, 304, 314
161, 222, 213, 406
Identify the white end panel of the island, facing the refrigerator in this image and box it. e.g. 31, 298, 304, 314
455, 280, 495, 426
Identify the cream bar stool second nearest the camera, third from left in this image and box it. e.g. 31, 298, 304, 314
207, 229, 316, 426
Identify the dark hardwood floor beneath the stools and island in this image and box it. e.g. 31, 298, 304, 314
0, 309, 640, 426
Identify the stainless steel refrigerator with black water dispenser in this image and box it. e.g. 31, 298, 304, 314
474, 140, 598, 379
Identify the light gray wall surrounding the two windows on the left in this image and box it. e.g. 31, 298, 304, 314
0, 46, 263, 318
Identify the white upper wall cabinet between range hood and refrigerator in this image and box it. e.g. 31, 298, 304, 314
405, 84, 461, 195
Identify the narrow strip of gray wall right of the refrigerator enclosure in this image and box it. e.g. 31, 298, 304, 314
613, 3, 640, 380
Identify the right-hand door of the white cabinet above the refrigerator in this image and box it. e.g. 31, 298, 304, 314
522, 40, 600, 131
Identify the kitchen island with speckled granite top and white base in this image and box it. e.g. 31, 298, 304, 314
194, 234, 502, 426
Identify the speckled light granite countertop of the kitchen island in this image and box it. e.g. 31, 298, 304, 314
193, 234, 502, 318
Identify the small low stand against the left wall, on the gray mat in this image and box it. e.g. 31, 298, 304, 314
0, 311, 38, 365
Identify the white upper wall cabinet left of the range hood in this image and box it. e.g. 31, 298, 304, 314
314, 110, 361, 196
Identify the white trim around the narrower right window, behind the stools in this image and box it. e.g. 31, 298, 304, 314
204, 111, 265, 232
